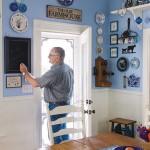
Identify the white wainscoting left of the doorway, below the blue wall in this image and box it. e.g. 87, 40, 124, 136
0, 97, 35, 150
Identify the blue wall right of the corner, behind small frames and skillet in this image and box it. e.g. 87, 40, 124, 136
109, 0, 150, 91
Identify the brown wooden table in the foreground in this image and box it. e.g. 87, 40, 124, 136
40, 132, 150, 150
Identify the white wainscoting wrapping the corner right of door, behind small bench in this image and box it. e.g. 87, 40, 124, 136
92, 89, 142, 135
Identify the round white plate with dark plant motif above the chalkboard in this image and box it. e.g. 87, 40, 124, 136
10, 13, 28, 32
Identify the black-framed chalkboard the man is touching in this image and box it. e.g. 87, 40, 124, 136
4, 36, 31, 73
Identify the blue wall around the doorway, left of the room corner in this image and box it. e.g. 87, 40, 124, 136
2, 0, 109, 96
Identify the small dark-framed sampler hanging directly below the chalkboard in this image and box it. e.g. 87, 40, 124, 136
6, 75, 22, 88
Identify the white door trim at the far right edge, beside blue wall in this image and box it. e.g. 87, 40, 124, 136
142, 29, 150, 126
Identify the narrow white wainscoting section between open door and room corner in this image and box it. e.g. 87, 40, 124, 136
92, 89, 108, 135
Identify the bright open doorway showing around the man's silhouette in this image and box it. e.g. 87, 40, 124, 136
41, 32, 75, 146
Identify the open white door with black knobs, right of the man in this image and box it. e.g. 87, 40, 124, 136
76, 29, 92, 136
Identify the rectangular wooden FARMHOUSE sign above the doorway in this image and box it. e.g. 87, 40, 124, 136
46, 5, 82, 22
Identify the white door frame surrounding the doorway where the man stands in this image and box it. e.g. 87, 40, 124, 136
32, 20, 92, 147
